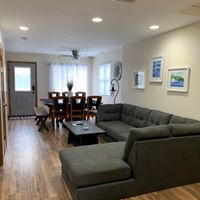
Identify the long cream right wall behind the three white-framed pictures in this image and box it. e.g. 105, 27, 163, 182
122, 23, 200, 120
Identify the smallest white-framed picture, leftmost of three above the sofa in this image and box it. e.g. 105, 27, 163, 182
132, 71, 145, 89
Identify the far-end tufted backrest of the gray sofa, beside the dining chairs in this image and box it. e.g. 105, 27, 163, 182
96, 104, 122, 123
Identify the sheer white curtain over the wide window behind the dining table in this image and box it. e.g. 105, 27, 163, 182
49, 63, 88, 93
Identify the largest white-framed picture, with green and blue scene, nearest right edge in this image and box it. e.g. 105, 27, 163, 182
167, 67, 190, 92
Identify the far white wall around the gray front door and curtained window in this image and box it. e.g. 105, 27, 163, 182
6, 52, 92, 105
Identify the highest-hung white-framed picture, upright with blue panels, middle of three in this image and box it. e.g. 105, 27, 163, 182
150, 56, 163, 82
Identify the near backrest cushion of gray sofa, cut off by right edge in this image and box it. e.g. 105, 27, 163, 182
170, 123, 200, 137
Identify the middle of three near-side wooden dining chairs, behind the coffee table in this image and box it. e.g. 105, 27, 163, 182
70, 96, 85, 121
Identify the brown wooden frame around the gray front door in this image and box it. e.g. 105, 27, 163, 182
7, 60, 38, 116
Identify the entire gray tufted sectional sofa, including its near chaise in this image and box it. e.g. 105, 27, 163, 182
59, 104, 200, 200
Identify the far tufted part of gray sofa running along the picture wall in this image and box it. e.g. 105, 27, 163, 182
97, 104, 198, 141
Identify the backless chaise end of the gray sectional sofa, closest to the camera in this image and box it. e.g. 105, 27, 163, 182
59, 142, 134, 200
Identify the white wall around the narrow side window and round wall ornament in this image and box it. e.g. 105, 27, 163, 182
93, 49, 123, 103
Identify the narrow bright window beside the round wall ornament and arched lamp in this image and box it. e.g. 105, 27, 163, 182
99, 63, 111, 95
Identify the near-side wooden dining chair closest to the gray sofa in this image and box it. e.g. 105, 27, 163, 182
86, 96, 102, 120
